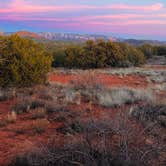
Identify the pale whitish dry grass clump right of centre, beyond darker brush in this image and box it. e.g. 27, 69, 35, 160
96, 88, 154, 107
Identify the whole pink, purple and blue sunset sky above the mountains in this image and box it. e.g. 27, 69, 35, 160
0, 0, 166, 40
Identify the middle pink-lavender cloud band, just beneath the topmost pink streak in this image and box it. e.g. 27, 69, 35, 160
0, 13, 166, 24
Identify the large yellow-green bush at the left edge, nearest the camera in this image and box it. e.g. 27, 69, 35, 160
0, 35, 52, 86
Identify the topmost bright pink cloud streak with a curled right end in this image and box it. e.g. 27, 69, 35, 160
0, 0, 164, 13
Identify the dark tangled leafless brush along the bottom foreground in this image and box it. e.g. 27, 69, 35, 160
10, 111, 164, 166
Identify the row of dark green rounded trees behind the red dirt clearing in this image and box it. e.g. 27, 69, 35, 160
53, 40, 145, 68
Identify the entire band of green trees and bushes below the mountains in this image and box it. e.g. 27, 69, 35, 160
0, 35, 166, 86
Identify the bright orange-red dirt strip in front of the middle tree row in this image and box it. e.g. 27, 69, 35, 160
48, 74, 148, 88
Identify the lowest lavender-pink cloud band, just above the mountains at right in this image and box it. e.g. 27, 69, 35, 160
37, 22, 166, 37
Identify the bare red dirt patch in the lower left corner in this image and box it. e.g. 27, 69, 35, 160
0, 101, 61, 166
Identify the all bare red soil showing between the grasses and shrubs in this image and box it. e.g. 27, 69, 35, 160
0, 67, 165, 166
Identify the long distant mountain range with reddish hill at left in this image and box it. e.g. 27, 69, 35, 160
0, 31, 166, 46
